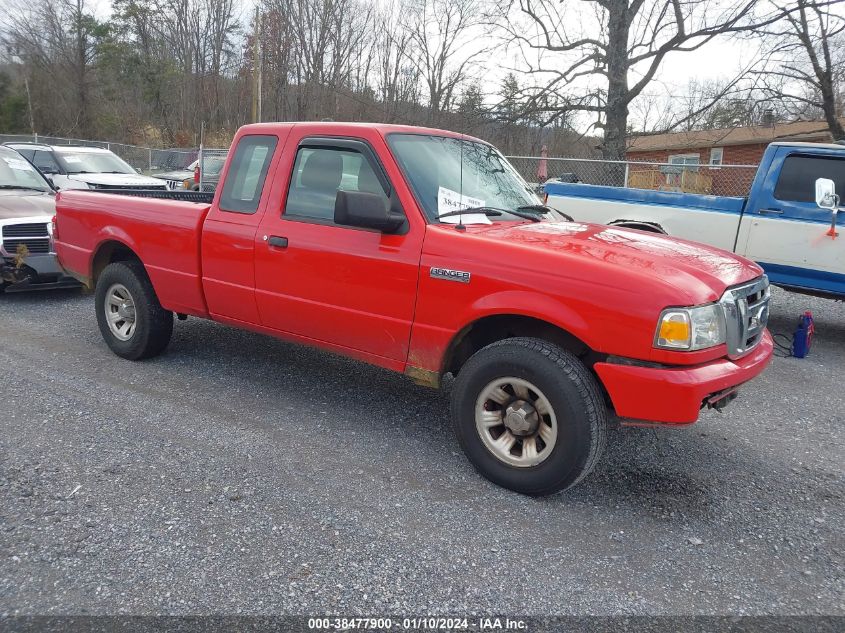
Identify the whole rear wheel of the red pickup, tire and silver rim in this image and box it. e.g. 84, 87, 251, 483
94, 261, 173, 360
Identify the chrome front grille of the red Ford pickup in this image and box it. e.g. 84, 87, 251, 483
720, 275, 769, 359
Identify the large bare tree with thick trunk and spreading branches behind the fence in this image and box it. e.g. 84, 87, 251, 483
498, 0, 777, 159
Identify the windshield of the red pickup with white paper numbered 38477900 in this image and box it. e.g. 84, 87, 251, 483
387, 134, 540, 221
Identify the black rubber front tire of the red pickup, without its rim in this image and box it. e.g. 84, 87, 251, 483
452, 338, 607, 496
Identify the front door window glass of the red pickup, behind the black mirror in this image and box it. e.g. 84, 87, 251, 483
284, 147, 387, 222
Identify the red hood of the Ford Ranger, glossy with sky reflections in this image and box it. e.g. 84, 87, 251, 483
468, 222, 763, 304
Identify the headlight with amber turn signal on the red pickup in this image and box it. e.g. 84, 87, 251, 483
654, 303, 725, 351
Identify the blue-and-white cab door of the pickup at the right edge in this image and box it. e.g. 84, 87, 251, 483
737, 147, 845, 294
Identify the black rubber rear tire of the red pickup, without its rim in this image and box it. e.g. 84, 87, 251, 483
94, 261, 173, 360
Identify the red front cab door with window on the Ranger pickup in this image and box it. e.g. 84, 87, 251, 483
255, 126, 425, 366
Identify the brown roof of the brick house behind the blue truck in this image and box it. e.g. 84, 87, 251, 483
628, 118, 845, 152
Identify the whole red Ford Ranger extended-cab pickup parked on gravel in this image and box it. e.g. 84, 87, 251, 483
54, 123, 772, 495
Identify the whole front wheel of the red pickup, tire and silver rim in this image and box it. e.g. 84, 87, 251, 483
452, 338, 607, 496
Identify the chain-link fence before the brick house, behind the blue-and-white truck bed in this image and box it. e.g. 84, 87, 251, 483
507, 156, 757, 197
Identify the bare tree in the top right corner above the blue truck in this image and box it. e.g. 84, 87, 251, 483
756, 0, 845, 139
